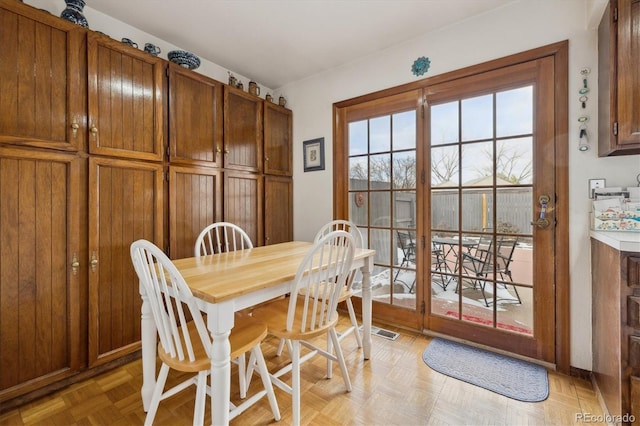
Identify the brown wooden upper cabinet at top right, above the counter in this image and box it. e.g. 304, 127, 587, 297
598, 0, 640, 156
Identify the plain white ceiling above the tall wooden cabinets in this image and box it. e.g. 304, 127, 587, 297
87, 0, 517, 89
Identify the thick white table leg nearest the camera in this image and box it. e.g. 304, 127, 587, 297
207, 303, 234, 425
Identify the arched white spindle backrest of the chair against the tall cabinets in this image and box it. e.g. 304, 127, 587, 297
195, 222, 253, 256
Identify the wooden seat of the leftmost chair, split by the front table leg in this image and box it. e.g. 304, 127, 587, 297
158, 315, 267, 373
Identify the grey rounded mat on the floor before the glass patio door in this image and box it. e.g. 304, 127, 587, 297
422, 337, 549, 402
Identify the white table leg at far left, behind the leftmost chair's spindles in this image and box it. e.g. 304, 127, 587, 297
140, 285, 158, 412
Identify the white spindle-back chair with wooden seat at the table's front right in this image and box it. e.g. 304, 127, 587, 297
247, 231, 355, 425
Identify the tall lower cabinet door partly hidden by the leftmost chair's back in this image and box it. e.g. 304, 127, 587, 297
87, 157, 164, 365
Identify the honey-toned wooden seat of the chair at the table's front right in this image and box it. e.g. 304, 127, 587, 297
253, 295, 338, 340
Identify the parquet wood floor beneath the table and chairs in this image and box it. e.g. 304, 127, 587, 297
0, 318, 603, 426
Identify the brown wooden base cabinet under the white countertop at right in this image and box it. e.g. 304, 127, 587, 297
591, 238, 640, 424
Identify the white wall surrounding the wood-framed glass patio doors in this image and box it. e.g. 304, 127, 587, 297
281, 0, 640, 370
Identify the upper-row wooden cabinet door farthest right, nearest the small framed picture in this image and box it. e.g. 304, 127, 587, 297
264, 102, 293, 176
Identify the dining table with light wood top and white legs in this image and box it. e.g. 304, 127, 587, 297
140, 241, 375, 425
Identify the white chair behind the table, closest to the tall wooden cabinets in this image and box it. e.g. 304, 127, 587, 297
194, 222, 253, 398
